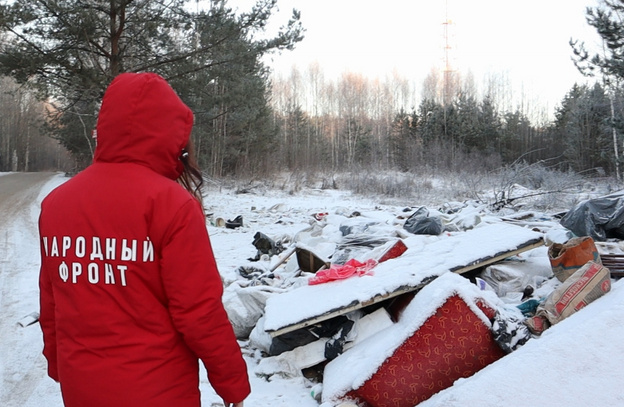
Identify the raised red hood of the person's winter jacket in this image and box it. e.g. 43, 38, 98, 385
93, 73, 193, 179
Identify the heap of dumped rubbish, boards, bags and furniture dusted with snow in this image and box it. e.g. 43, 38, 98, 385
214, 192, 624, 407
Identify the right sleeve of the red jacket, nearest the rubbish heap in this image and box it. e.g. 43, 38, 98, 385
161, 199, 251, 403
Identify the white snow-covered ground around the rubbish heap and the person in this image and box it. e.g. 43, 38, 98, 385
0, 175, 624, 407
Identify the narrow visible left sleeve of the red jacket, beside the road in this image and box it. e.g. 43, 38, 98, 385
39, 231, 59, 382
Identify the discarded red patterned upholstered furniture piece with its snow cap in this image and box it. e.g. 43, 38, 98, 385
323, 273, 505, 407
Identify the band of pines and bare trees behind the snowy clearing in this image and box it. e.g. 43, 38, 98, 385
0, 0, 624, 184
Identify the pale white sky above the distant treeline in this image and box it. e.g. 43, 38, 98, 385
228, 0, 598, 117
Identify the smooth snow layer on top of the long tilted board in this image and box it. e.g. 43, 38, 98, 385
264, 223, 541, 331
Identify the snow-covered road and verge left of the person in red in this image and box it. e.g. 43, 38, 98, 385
0, 173, 62, 407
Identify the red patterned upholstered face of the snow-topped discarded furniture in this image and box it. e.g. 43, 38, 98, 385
349, 295, 505, 407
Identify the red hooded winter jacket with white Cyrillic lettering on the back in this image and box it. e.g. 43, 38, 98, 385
39, 74, 250, 407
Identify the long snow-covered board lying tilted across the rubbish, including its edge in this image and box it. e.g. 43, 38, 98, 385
265, 223, 543, 337
